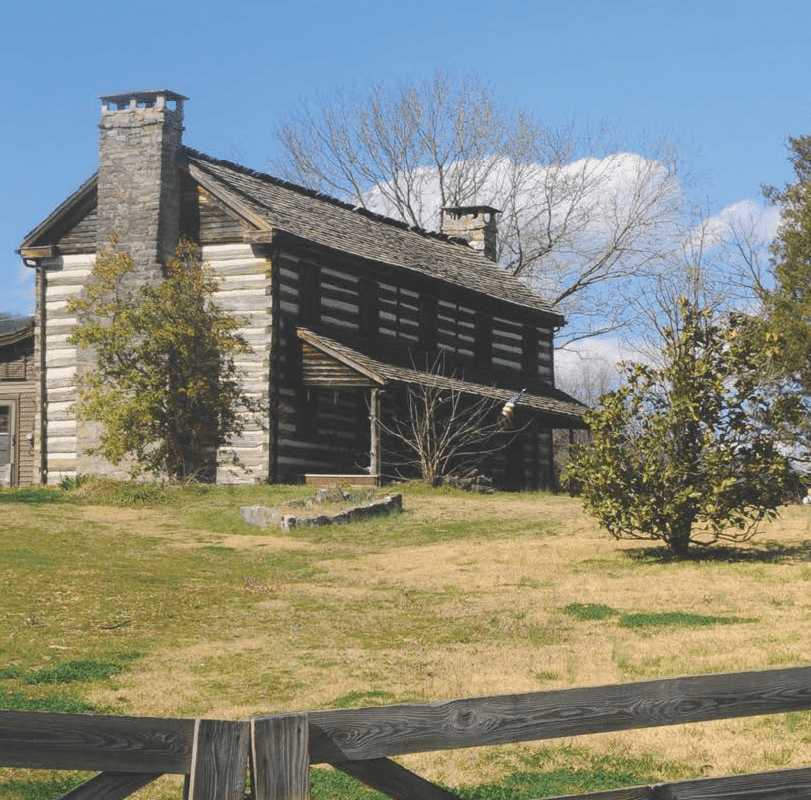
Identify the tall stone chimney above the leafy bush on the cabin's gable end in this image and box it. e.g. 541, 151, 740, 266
96, 89, 188, 280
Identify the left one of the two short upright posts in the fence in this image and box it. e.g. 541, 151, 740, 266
188, 719, 250, 800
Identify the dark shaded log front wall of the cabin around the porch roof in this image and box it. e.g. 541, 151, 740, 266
274, 248, 553, 489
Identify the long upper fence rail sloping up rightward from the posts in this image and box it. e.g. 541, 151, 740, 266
302, 667, 811, 763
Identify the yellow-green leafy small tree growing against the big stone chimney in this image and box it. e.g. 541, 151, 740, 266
70, 241, 255, 479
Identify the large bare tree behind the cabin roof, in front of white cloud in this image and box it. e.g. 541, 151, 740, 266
275, 73, 683, 345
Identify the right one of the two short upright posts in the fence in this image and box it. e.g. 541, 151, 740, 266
251, 713, 310, 800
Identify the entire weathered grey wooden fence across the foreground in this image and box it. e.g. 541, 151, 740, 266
0, 667, 811, 800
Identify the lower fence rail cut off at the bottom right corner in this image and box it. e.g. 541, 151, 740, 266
547, 767, 811, 800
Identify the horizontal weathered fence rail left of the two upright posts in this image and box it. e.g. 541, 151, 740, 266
0, 711, 194, 774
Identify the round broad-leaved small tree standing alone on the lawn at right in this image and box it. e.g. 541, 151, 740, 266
568, 301, 790, 558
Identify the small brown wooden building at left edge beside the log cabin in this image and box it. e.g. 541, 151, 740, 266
0, 317, 37, 486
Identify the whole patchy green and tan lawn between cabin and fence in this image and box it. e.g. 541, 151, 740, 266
0, 484, 811, 800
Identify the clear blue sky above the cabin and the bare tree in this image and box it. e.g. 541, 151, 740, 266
0, 0, 811, 313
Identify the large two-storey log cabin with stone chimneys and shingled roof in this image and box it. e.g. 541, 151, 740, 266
19, 89, 585, 489
